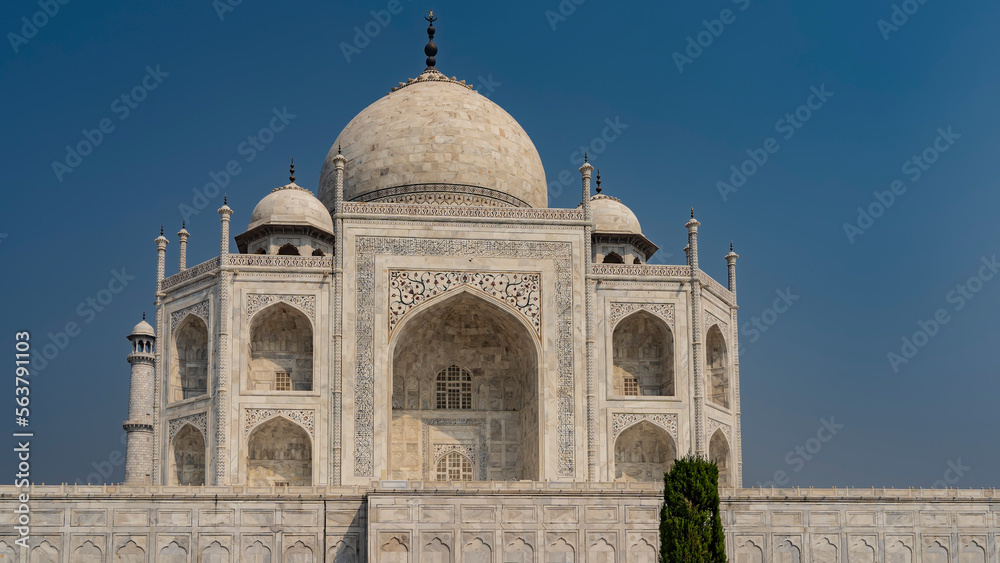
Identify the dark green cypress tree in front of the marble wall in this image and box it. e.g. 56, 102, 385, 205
660, 455, 726, 563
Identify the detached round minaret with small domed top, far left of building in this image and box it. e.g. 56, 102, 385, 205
122, 313, 156, 485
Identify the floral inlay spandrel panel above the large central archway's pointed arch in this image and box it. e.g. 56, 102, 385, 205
389, 270, 541, 334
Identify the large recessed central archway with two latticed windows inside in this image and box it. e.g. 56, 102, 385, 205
389, 289, 539, 481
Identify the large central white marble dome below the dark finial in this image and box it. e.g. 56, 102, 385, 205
319, 68, 548, 211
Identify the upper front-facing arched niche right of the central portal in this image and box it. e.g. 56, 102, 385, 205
611, 310, 674, 397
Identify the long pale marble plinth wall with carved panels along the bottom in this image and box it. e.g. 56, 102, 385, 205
0, 481, 1000, 563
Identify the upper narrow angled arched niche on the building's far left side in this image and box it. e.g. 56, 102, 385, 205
170, 315, 208, 401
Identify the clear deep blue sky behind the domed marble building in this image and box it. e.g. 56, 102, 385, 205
0, 0, 1000, 487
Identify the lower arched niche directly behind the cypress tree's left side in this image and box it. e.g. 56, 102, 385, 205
615, 420, 677, 482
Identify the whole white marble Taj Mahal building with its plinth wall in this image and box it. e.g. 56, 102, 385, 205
0, 15, 1000, 563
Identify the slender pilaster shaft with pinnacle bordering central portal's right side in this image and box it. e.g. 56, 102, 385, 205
580, 153, 600, 481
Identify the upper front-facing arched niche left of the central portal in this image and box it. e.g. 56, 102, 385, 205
247, 302, 313, 392
